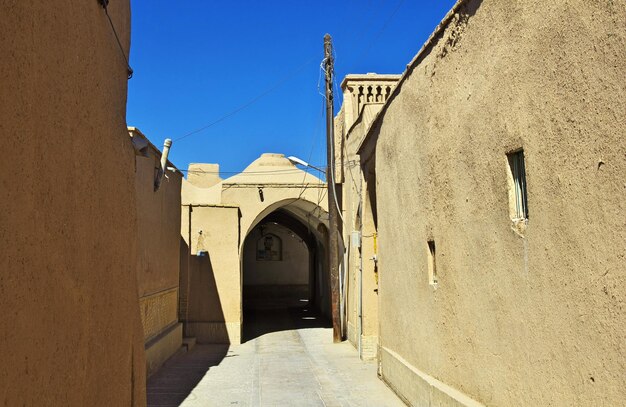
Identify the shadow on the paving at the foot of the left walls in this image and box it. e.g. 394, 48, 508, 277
147, 345, 228, 407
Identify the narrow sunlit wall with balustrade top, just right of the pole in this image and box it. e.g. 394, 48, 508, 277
335, 74, 400, 359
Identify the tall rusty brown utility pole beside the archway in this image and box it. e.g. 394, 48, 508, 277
324, 34, 342, 342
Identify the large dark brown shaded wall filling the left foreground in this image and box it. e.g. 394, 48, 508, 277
0, 0, 146, 406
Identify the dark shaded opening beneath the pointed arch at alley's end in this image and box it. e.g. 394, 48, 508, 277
241, 207, 330, 341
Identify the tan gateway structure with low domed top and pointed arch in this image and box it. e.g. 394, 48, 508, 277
179, 154, 330, 343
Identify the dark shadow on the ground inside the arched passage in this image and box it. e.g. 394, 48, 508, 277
241, 298, 332, 342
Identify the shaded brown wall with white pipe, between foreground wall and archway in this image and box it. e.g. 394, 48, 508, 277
131, 129, 182, 375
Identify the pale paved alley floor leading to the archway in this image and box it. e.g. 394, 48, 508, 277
148, 302, 404, 407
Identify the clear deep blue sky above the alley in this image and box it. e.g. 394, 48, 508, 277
127, 0, 455, 176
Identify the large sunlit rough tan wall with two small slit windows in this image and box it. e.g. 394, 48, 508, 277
376, 0, 626, 406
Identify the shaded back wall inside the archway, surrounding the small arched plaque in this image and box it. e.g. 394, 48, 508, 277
243, 224, 309, 286
